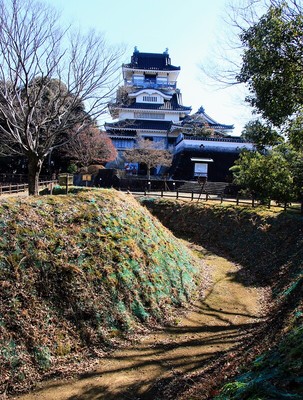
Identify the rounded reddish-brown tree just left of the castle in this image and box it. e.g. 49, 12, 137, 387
63, 126, 117, 170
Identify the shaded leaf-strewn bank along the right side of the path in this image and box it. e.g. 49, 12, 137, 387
143, 199, 303, 400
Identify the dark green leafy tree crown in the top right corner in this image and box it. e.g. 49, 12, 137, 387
237, 1, 303, 126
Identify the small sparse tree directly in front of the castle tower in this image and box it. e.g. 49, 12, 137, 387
124, 138, 172, 179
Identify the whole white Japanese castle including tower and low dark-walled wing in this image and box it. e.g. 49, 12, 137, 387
105, 48, 253, 181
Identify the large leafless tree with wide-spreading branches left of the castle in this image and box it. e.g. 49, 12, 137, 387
0, 0, 122, 195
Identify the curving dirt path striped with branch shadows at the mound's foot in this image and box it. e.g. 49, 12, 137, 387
18, 248, 261, 400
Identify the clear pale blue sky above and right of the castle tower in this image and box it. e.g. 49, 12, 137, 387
42, 0, 251, 135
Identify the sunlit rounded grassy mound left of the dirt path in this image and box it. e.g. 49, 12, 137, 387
0, 190, 204, 397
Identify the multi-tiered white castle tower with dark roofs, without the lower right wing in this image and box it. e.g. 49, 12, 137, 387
105, 47, 191, 152
